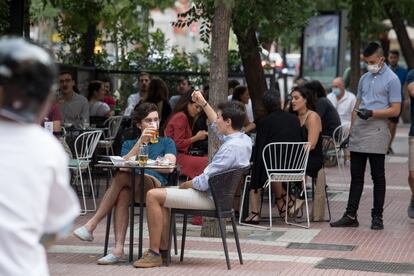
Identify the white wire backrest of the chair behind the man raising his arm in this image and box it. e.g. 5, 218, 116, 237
262, 142, 310, 181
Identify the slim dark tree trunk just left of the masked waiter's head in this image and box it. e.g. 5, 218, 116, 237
348, 0, 362, 94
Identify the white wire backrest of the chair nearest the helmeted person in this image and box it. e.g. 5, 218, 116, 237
75, 130, 102, 161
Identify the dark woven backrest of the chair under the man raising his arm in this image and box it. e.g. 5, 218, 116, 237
208, 166, 250, 216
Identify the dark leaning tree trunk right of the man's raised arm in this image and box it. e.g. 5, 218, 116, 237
234, 26, 267, 118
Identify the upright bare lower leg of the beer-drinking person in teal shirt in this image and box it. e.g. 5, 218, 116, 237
112, 187, 131, 257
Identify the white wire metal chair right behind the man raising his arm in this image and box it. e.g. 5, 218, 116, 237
239, 142, 310, 229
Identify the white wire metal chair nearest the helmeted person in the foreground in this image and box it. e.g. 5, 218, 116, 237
69, 130, 102, 215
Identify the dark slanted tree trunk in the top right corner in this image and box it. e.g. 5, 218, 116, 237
383, 1, 414, 69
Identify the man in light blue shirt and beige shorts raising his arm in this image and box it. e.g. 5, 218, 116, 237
134, 91, 252, 268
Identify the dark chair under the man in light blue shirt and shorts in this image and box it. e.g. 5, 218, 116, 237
167, 166, 250, 269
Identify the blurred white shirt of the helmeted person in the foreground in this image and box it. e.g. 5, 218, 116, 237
0, 121, 80, 276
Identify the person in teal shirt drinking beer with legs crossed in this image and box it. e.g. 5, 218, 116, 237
73, 103, 177, 264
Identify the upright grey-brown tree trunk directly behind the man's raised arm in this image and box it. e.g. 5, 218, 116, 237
201, 0, 231, 237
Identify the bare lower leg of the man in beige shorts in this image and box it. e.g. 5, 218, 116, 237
146, 188, 167, 253
